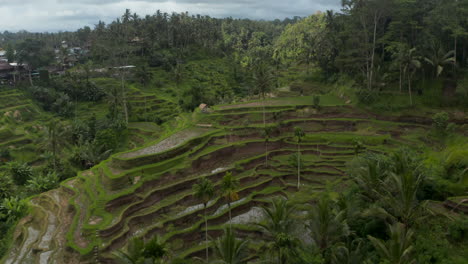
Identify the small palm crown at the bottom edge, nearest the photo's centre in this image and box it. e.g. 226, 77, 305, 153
212, 228, 248, 264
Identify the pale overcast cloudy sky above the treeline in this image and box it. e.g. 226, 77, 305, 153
0, 0, 341, 32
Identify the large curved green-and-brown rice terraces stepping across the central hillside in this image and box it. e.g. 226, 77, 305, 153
6, 98, 462, 263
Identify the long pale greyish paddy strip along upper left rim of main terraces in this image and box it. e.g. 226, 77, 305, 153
120, 127, 210, 159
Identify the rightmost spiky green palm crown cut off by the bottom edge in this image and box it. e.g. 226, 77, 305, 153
367, 223, 416, 264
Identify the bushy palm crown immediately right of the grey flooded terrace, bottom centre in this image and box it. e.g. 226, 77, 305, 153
258, 198, 299, 263
